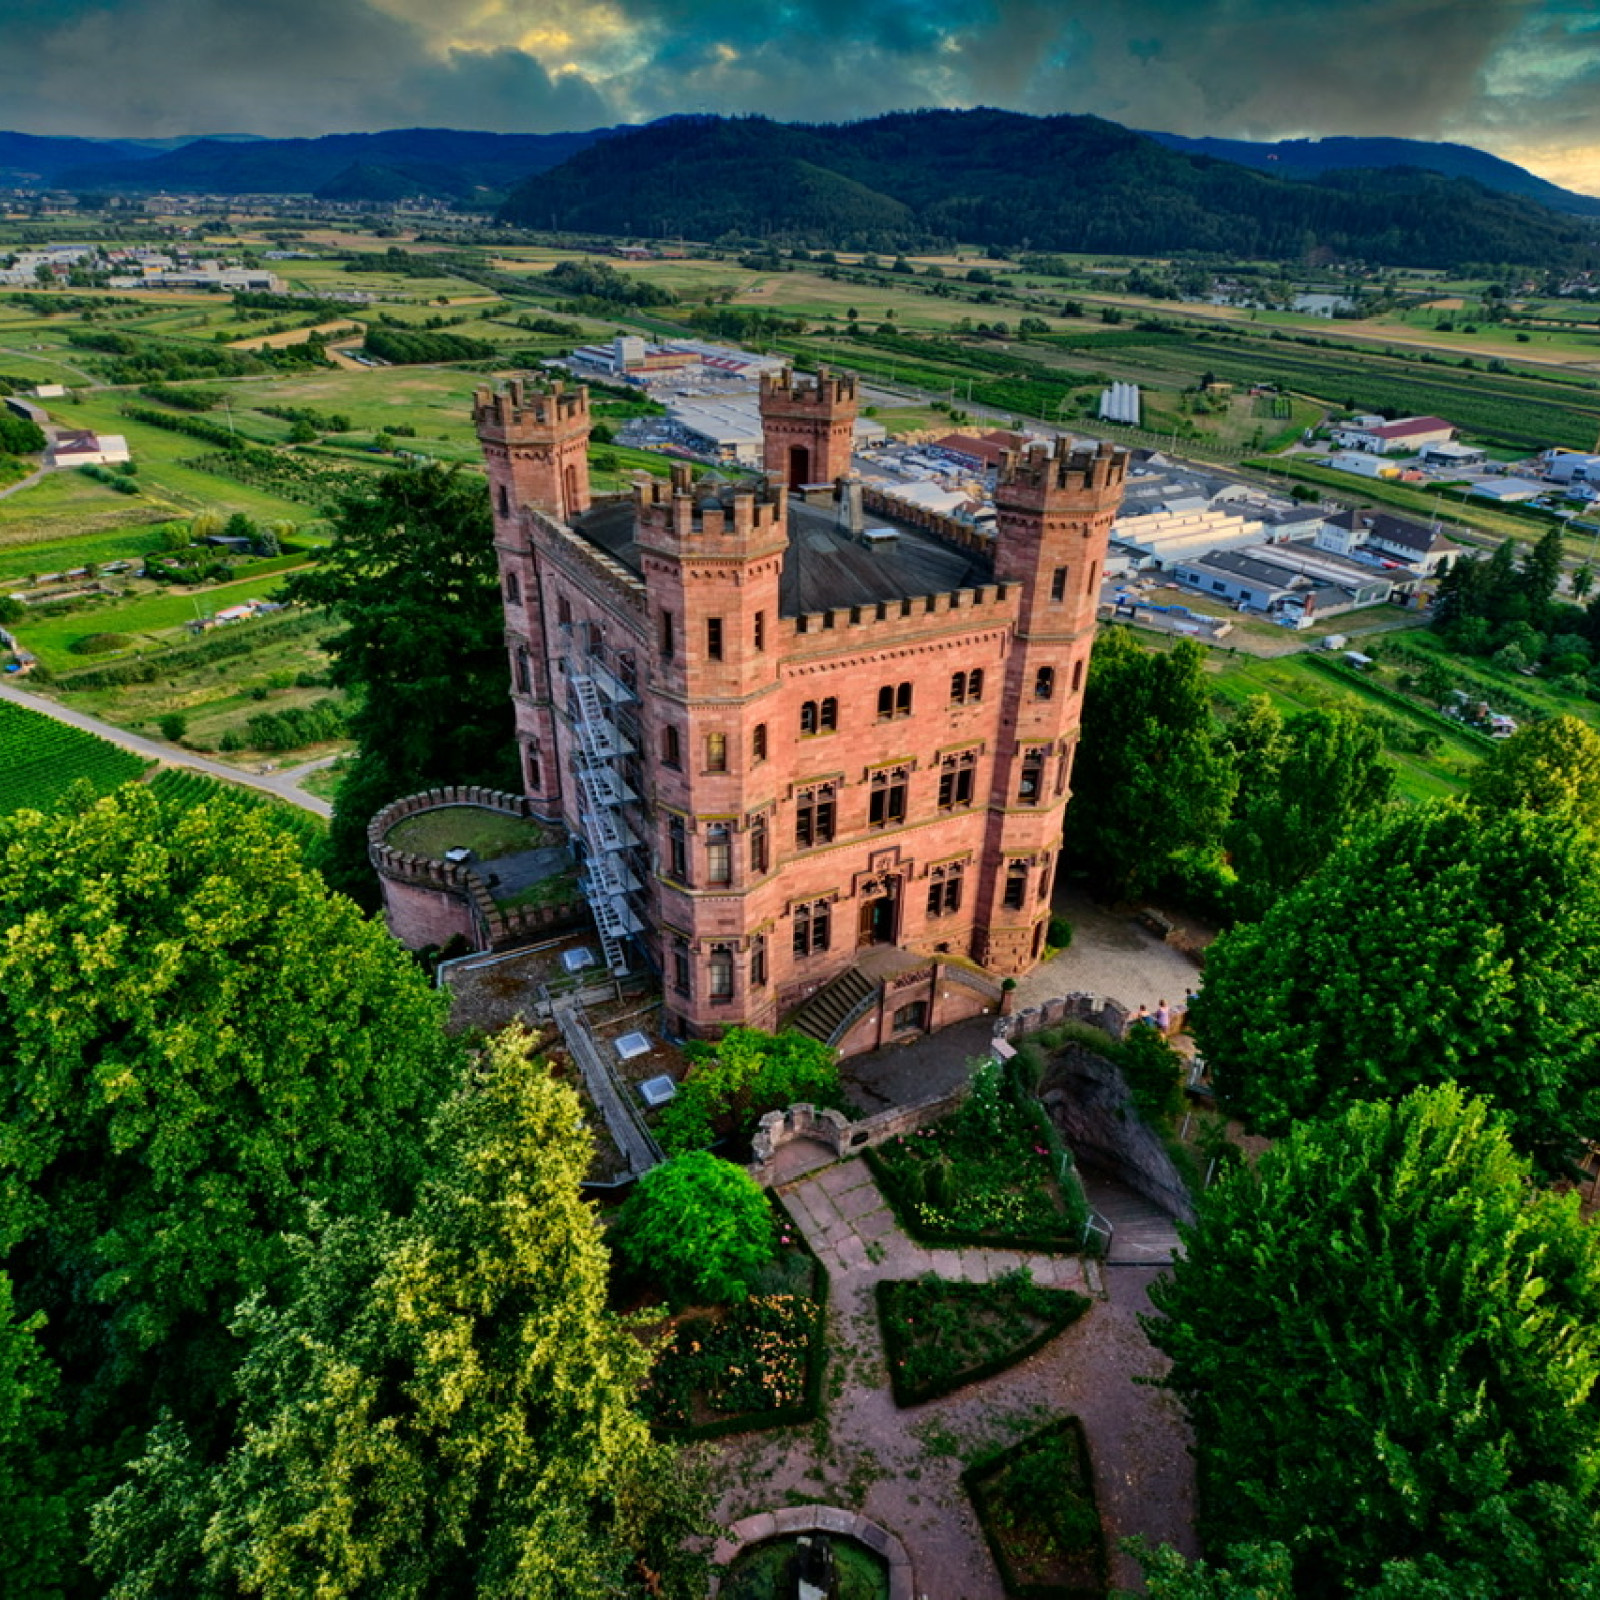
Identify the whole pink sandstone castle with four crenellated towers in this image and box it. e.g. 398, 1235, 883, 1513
474, 370, 1126, 1048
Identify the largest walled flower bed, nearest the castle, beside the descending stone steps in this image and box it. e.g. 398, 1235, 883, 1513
866, 1066, 1088, 1251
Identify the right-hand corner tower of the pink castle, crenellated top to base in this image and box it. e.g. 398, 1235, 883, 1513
979, 440, 1128, 973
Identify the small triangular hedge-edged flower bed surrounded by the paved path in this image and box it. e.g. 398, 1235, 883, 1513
877, 1269, 1091, 1405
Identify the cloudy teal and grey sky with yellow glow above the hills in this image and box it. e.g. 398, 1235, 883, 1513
0, 0, 1600, 194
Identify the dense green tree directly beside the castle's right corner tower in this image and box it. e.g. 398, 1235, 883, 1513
1066, 627, 1235, 894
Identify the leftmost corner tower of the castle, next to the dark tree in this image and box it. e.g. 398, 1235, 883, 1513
472, 379, 601, 818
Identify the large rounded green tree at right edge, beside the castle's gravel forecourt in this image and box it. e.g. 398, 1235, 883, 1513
1190, 803, 1600, 1170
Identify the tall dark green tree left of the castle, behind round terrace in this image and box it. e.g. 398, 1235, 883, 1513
286, 464, 517, 902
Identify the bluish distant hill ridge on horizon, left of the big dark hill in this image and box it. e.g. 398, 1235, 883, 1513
58, 128, 611, 200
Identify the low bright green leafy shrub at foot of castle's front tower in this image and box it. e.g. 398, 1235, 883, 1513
661, 1027, 838, 1150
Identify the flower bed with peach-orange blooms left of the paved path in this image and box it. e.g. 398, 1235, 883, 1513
643, 1197, 827, 1438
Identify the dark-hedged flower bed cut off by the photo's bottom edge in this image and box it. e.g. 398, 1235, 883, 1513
962, 1416, 1106, 1600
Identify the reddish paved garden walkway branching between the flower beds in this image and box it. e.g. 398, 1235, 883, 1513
718, 1162, 1197, 1600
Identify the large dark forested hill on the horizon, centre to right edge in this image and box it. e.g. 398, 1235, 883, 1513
501, 110, 1600, 267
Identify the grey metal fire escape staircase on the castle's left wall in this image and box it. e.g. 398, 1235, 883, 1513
566, 651, 643, 976
